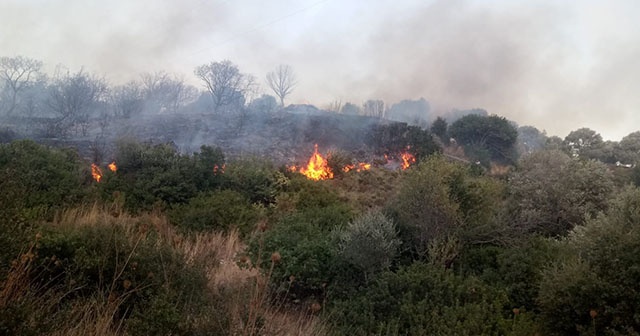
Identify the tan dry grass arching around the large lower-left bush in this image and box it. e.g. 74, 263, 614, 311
0, 204, 327, 336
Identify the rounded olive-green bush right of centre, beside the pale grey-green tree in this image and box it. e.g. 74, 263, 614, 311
390, 157, 503, 265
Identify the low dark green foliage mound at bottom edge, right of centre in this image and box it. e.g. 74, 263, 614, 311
334, 262, 505, 335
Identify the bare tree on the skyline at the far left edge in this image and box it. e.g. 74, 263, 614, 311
0, 56, 42, 115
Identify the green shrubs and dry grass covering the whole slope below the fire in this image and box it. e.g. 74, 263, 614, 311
0, 122, 640, 335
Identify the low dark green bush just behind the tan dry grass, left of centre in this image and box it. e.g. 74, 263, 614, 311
169, 190, 259, 235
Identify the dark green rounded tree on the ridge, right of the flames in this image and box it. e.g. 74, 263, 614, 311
449, 114, 518, 165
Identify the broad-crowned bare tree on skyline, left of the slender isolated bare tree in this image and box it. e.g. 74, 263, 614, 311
195, 60, 255, 113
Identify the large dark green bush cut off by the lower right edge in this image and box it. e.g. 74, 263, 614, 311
539, 188, 640, 335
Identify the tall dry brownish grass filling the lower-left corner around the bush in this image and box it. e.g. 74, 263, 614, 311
0, 204, 328, 336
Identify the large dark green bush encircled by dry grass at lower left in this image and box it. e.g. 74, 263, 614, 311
13, 211, 211, 335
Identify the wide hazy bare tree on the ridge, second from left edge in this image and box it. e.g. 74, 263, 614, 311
47, 70, 107, 136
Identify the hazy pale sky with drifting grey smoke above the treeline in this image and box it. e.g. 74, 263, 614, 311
0, 0, 640, 140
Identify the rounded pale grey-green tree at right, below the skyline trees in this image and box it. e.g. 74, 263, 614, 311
509, 150, 613, 236
